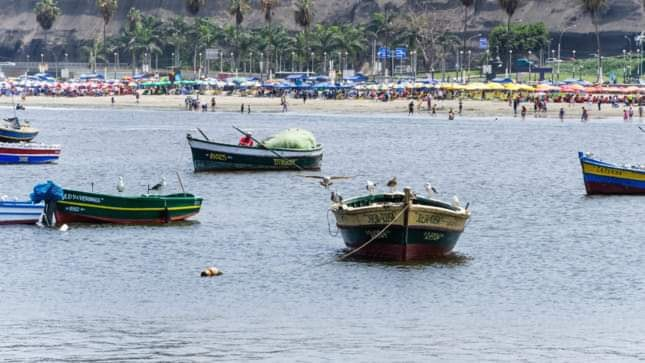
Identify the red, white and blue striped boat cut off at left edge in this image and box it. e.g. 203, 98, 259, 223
0, 142, 61, 164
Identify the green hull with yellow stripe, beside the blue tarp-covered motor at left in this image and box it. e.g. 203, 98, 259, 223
54, 190, 202, 224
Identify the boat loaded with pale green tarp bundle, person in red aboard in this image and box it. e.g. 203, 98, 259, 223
187, 128, 323, 172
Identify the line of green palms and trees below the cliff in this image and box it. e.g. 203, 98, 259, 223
34, 0, 620, 80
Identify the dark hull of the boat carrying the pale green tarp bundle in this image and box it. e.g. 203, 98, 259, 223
188, 136, 323, 172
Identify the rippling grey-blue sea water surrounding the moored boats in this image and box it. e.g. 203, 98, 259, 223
0, 108, 645, 362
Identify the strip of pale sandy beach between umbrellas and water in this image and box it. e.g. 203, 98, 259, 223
0, 95, 638, 120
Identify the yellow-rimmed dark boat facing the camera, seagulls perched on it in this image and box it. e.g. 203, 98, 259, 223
331, 188, 470, 261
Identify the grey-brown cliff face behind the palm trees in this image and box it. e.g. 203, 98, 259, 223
0, 0, 645, 60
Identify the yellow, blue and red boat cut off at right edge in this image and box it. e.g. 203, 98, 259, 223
578, 152, 645, 195
